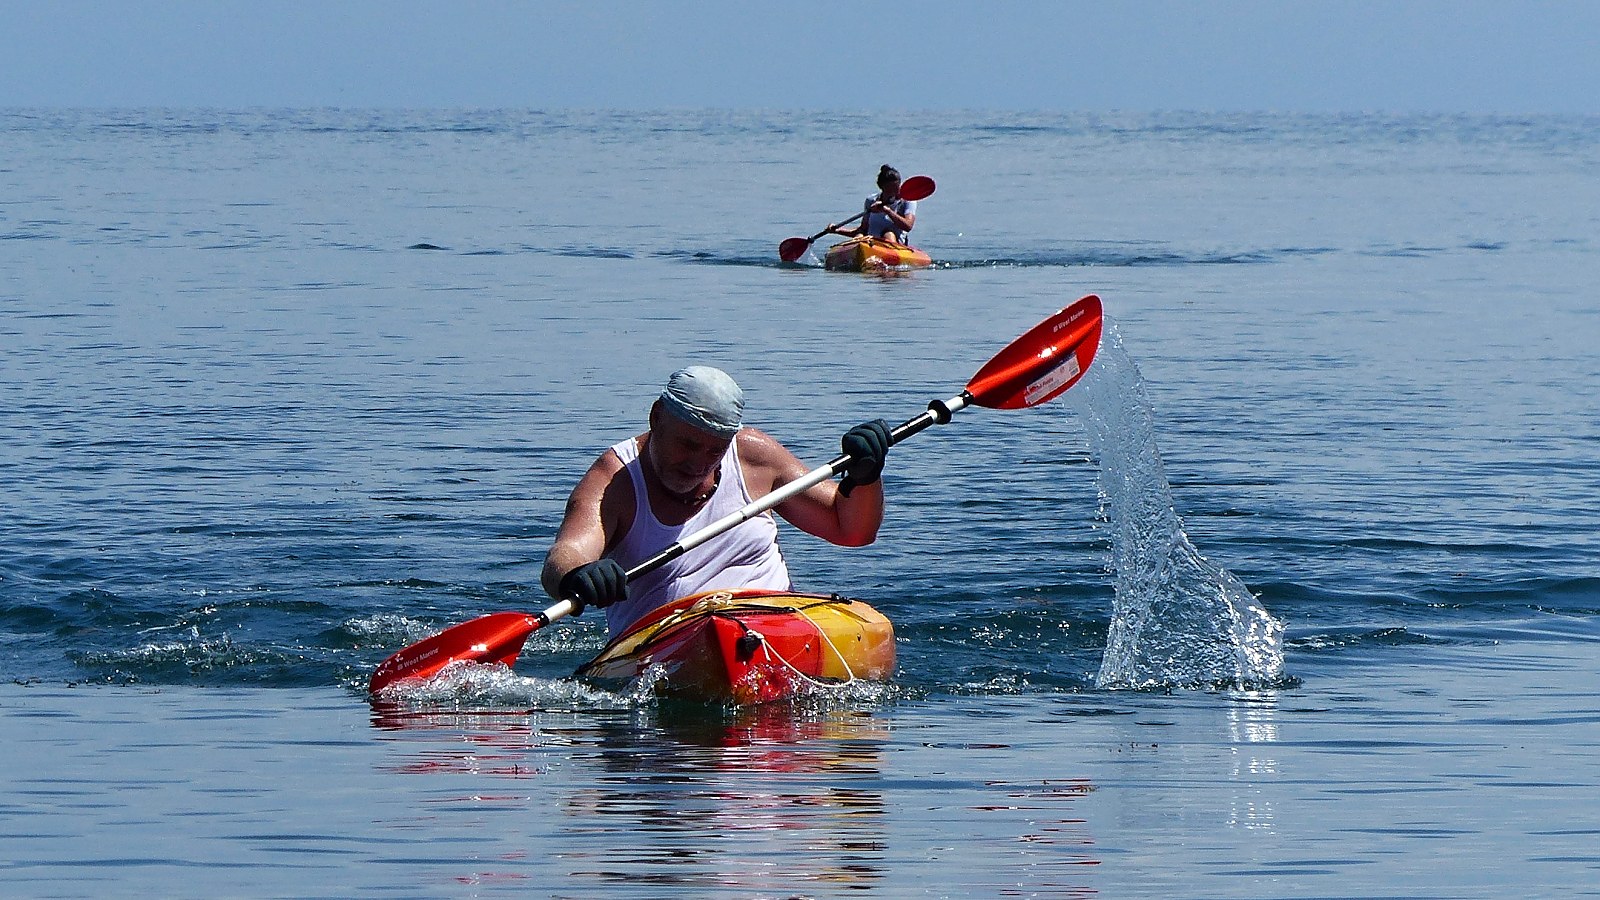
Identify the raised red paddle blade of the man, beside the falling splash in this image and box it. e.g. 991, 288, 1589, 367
966, 295, 1101, 410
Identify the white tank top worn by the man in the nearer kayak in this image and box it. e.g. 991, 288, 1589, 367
605, 437, 792, 636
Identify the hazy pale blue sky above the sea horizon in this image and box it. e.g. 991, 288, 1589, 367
0, 0, 1600, 114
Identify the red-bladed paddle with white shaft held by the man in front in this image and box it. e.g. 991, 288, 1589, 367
368, 294, 1101, 693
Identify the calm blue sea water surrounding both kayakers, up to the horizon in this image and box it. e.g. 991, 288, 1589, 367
0, 110, 1600, 897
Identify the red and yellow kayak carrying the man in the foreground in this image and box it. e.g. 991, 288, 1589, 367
576, 591, 894, 706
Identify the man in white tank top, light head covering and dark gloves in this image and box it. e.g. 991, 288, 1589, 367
541, 365, 890, 636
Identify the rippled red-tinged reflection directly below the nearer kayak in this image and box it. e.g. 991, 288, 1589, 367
562, 708, 885, 890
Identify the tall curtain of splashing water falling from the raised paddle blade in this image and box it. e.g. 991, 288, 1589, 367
1067, 319, 1283, 689
